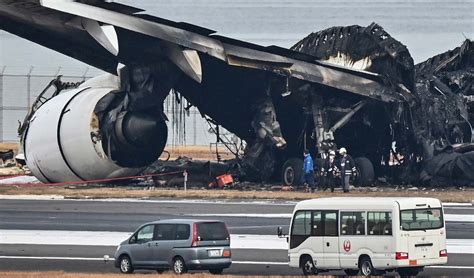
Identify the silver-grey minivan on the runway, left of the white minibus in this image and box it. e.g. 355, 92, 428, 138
114, 219, 232, 274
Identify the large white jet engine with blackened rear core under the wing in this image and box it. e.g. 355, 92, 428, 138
23, 86, 167, 183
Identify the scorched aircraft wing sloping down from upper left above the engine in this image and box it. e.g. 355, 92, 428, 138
0, 0, 406, 102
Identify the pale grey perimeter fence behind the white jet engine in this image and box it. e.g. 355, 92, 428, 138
0, 65, 230, 146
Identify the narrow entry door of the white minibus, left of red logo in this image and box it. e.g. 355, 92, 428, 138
322, 210, 340, 268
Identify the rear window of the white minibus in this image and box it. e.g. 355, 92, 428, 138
400, 208, 443, 231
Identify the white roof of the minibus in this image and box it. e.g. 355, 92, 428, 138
295, 197, 441, 210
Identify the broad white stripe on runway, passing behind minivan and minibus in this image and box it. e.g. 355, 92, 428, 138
0, 230, 474, 254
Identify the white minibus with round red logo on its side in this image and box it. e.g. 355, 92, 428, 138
278, 197, 448, 276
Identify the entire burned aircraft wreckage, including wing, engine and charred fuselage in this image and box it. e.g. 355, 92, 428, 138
0, 0, 474, 185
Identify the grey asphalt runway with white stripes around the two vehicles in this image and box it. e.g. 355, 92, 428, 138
0, 200, 474, 277
